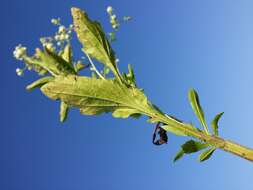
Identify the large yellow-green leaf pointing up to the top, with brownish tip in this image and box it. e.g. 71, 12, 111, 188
71, 7, 122, 81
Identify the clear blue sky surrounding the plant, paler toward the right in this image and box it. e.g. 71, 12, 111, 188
0, 0, 253, 190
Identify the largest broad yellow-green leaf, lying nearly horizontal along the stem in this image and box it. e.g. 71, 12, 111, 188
41, 75, 153, 118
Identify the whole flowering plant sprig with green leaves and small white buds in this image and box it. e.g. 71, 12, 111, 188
13, 6, 253, 161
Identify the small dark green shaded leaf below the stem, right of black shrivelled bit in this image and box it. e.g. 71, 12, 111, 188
181, 140, 209, 154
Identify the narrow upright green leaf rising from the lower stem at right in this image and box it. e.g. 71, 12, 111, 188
188, 89, 209, 133
